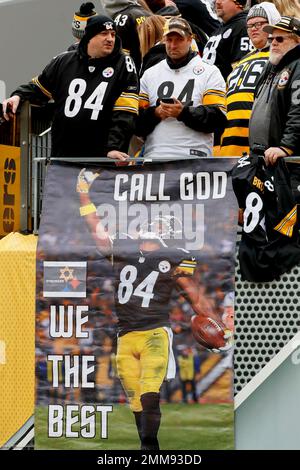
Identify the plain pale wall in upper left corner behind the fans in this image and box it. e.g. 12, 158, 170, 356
0, 0, 90, 102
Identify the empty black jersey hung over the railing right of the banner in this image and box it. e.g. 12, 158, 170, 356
232, 156, 300, 282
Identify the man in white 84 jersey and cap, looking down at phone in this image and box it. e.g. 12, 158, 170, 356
137, 18, 226, 158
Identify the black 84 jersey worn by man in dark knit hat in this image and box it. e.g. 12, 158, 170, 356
13, 38, 138, 158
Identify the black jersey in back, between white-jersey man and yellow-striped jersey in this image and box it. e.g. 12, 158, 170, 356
203, 12, 252, 80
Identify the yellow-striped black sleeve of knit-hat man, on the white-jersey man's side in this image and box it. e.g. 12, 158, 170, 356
106, 56, 139, 152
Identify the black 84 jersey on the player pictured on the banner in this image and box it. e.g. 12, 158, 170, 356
113, 238, 196, 335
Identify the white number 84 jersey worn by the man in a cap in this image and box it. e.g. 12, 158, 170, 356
140, 55, 225, 158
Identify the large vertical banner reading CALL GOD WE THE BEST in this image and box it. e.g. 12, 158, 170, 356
35, 159, 237, 450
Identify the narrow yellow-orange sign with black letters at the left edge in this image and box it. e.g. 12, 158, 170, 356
0, 145, 20, 236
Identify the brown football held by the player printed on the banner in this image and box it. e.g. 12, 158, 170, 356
191, 315, 226, 349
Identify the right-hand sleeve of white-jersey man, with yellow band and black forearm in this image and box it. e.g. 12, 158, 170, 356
178, 67, 226, 133
